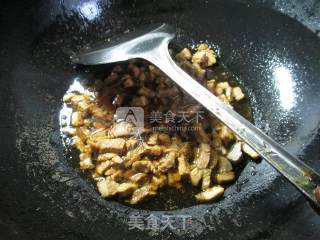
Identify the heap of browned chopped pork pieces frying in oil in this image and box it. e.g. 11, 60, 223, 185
63, 44, 258, 204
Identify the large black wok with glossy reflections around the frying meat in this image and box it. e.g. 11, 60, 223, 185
0, 1, 320, 239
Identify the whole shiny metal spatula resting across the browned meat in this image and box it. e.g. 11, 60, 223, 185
72, 24, 320, 207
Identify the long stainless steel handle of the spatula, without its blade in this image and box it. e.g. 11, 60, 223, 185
144, 44, 320, 207
